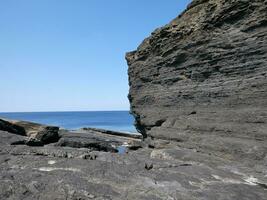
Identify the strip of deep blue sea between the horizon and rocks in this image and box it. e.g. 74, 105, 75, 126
0, 111, 137, 133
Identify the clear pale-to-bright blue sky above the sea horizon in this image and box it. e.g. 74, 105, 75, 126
0, 0, 193, 112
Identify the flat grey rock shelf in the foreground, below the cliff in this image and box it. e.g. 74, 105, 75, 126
0, 120, 267, 200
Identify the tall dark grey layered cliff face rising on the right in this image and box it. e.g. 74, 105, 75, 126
126, 0, 267, 157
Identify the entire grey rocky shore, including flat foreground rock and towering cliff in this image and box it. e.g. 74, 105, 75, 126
0, 0, 267, 200
